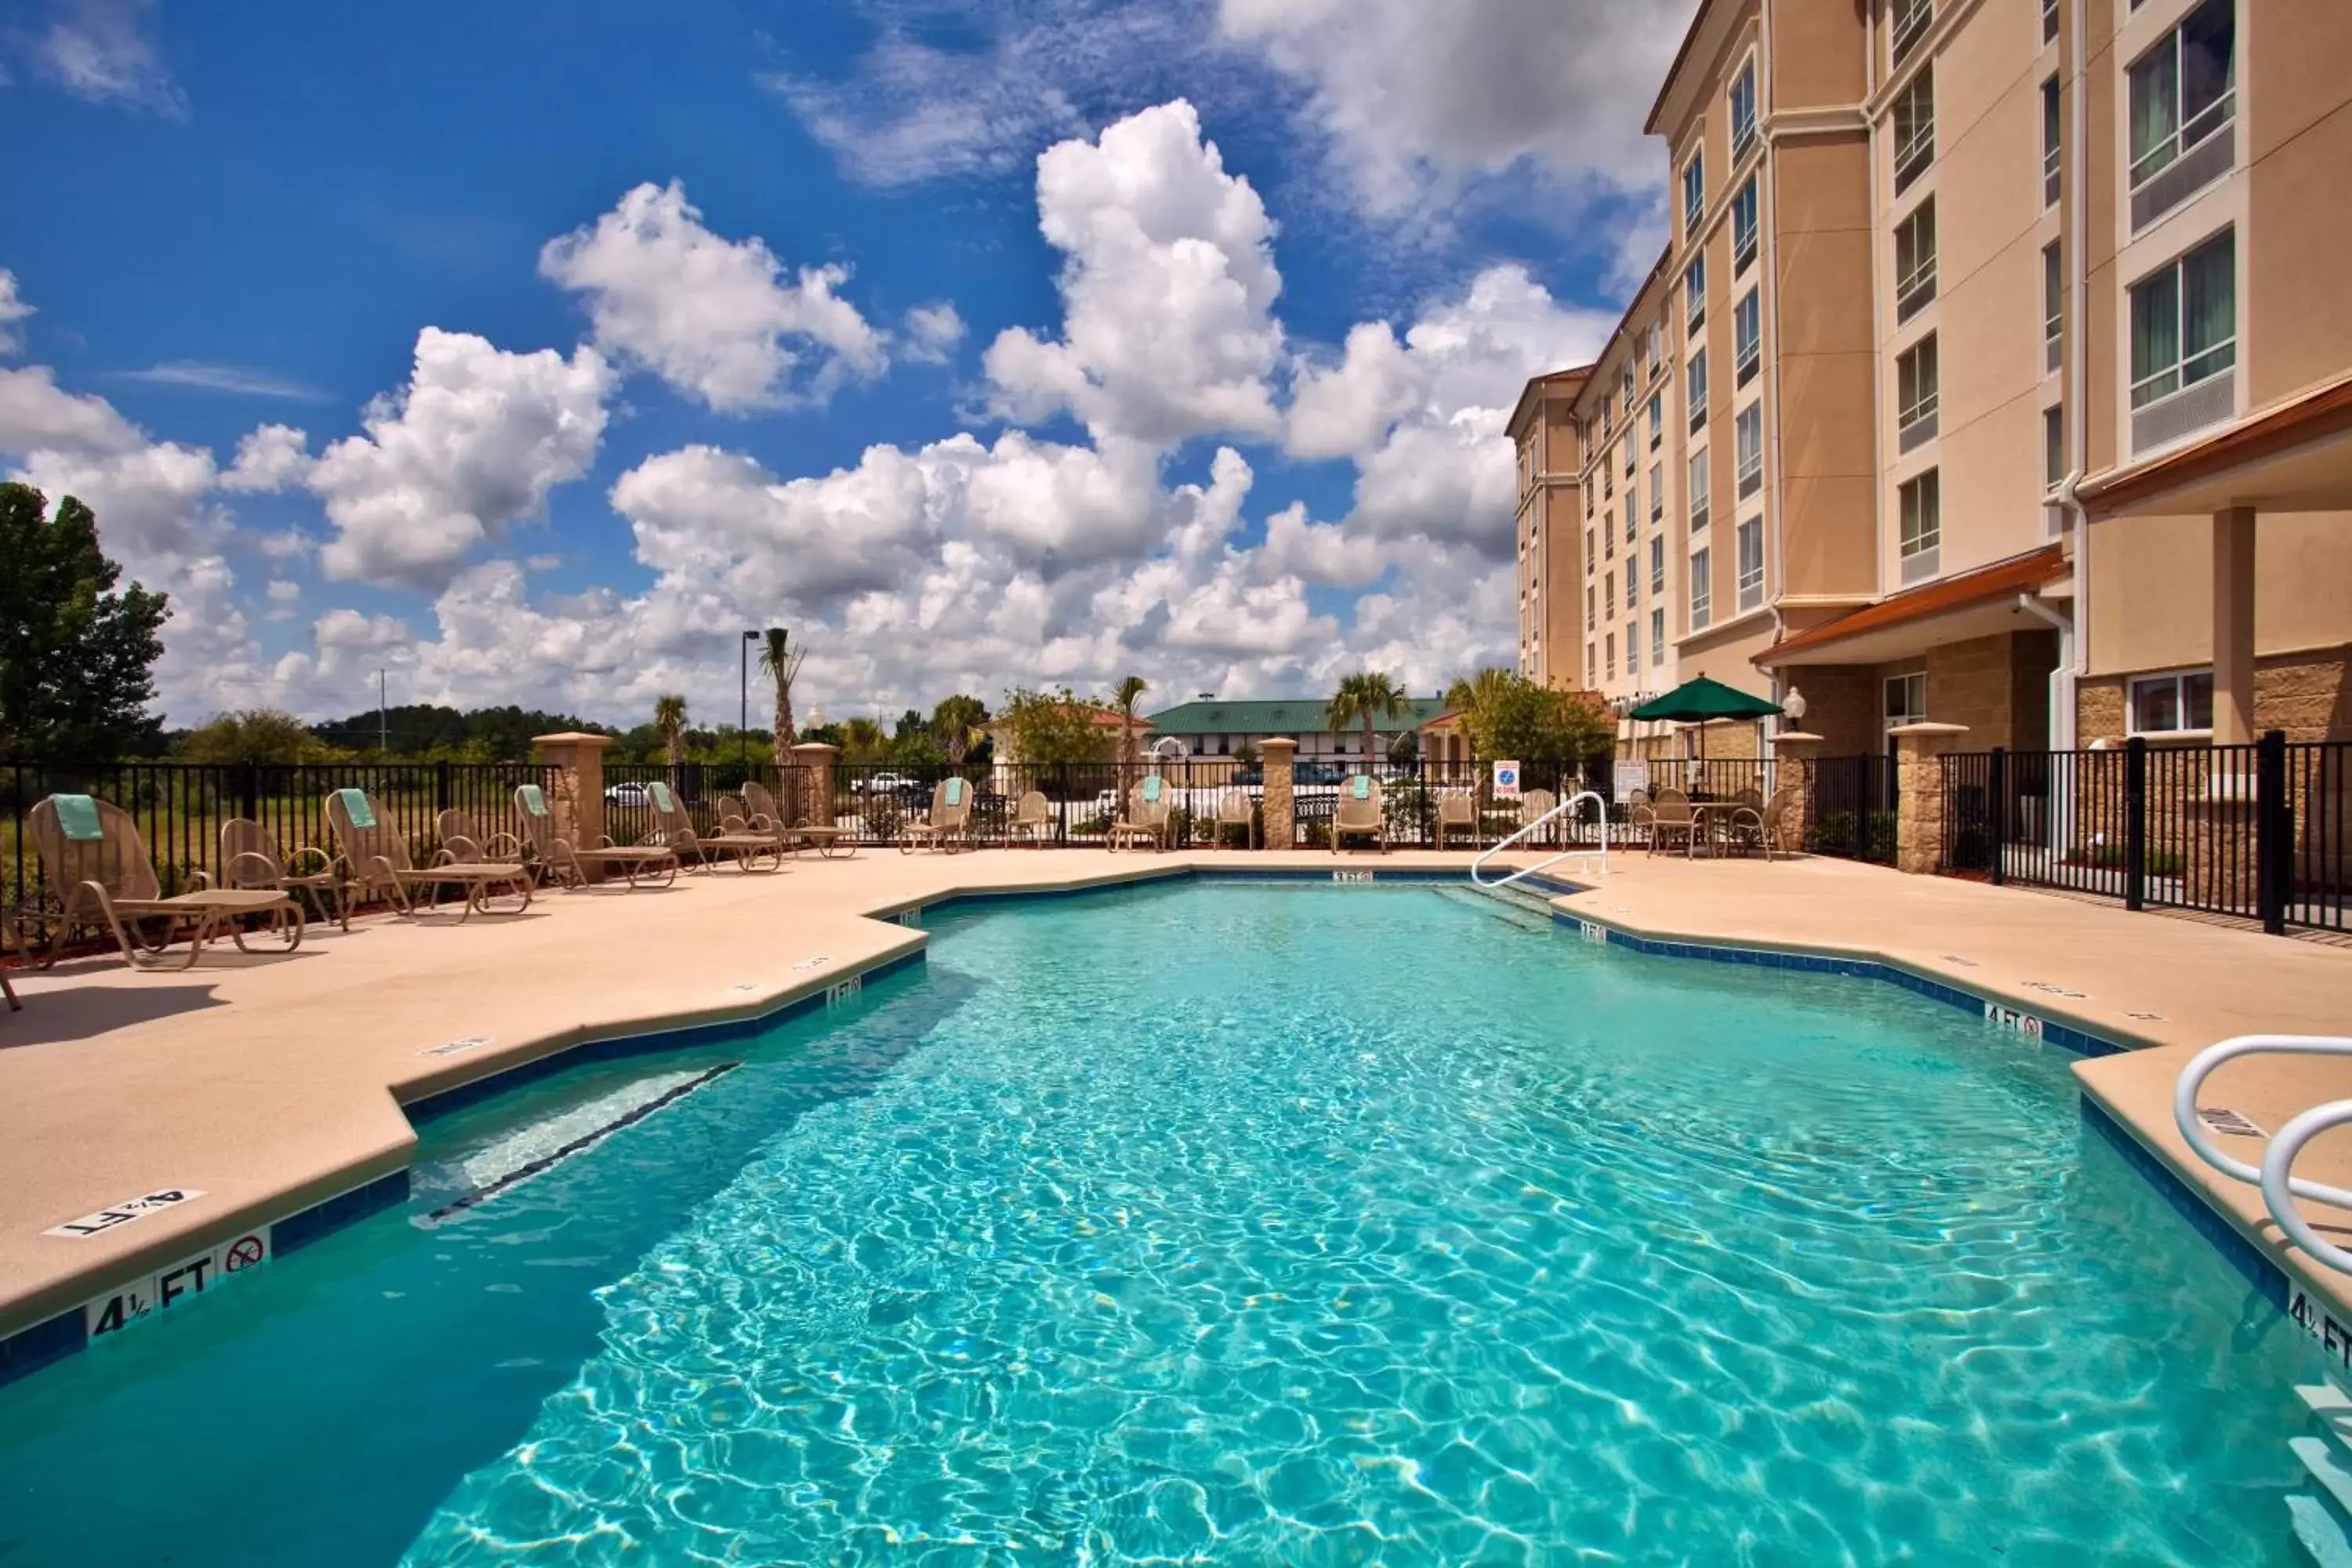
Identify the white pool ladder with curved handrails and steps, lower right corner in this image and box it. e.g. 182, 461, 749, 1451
2173, 1034, 2352, 1568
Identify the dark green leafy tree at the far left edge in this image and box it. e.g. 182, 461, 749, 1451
0, 485, 172, 762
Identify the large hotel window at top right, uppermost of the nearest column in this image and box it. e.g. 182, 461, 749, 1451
2131, 0, 2237, 230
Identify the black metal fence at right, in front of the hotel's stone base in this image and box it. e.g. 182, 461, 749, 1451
1940, 731, 2352, 933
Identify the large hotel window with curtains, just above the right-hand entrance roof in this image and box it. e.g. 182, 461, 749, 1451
2131, 230, 2237, 449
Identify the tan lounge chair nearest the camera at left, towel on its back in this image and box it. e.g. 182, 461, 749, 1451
26, 794, 303, 968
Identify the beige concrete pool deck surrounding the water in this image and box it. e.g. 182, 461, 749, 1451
0, 848, 2352, 1380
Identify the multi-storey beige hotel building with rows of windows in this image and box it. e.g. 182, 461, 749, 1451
1510, 0, 2352, 755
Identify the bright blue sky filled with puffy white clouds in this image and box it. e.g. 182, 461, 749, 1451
0, 0, 1689, 722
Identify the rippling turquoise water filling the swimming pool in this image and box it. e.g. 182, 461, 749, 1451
0, 884, 2310, 1568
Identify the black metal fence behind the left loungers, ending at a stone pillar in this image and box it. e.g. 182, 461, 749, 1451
0, 762, 548, 931
